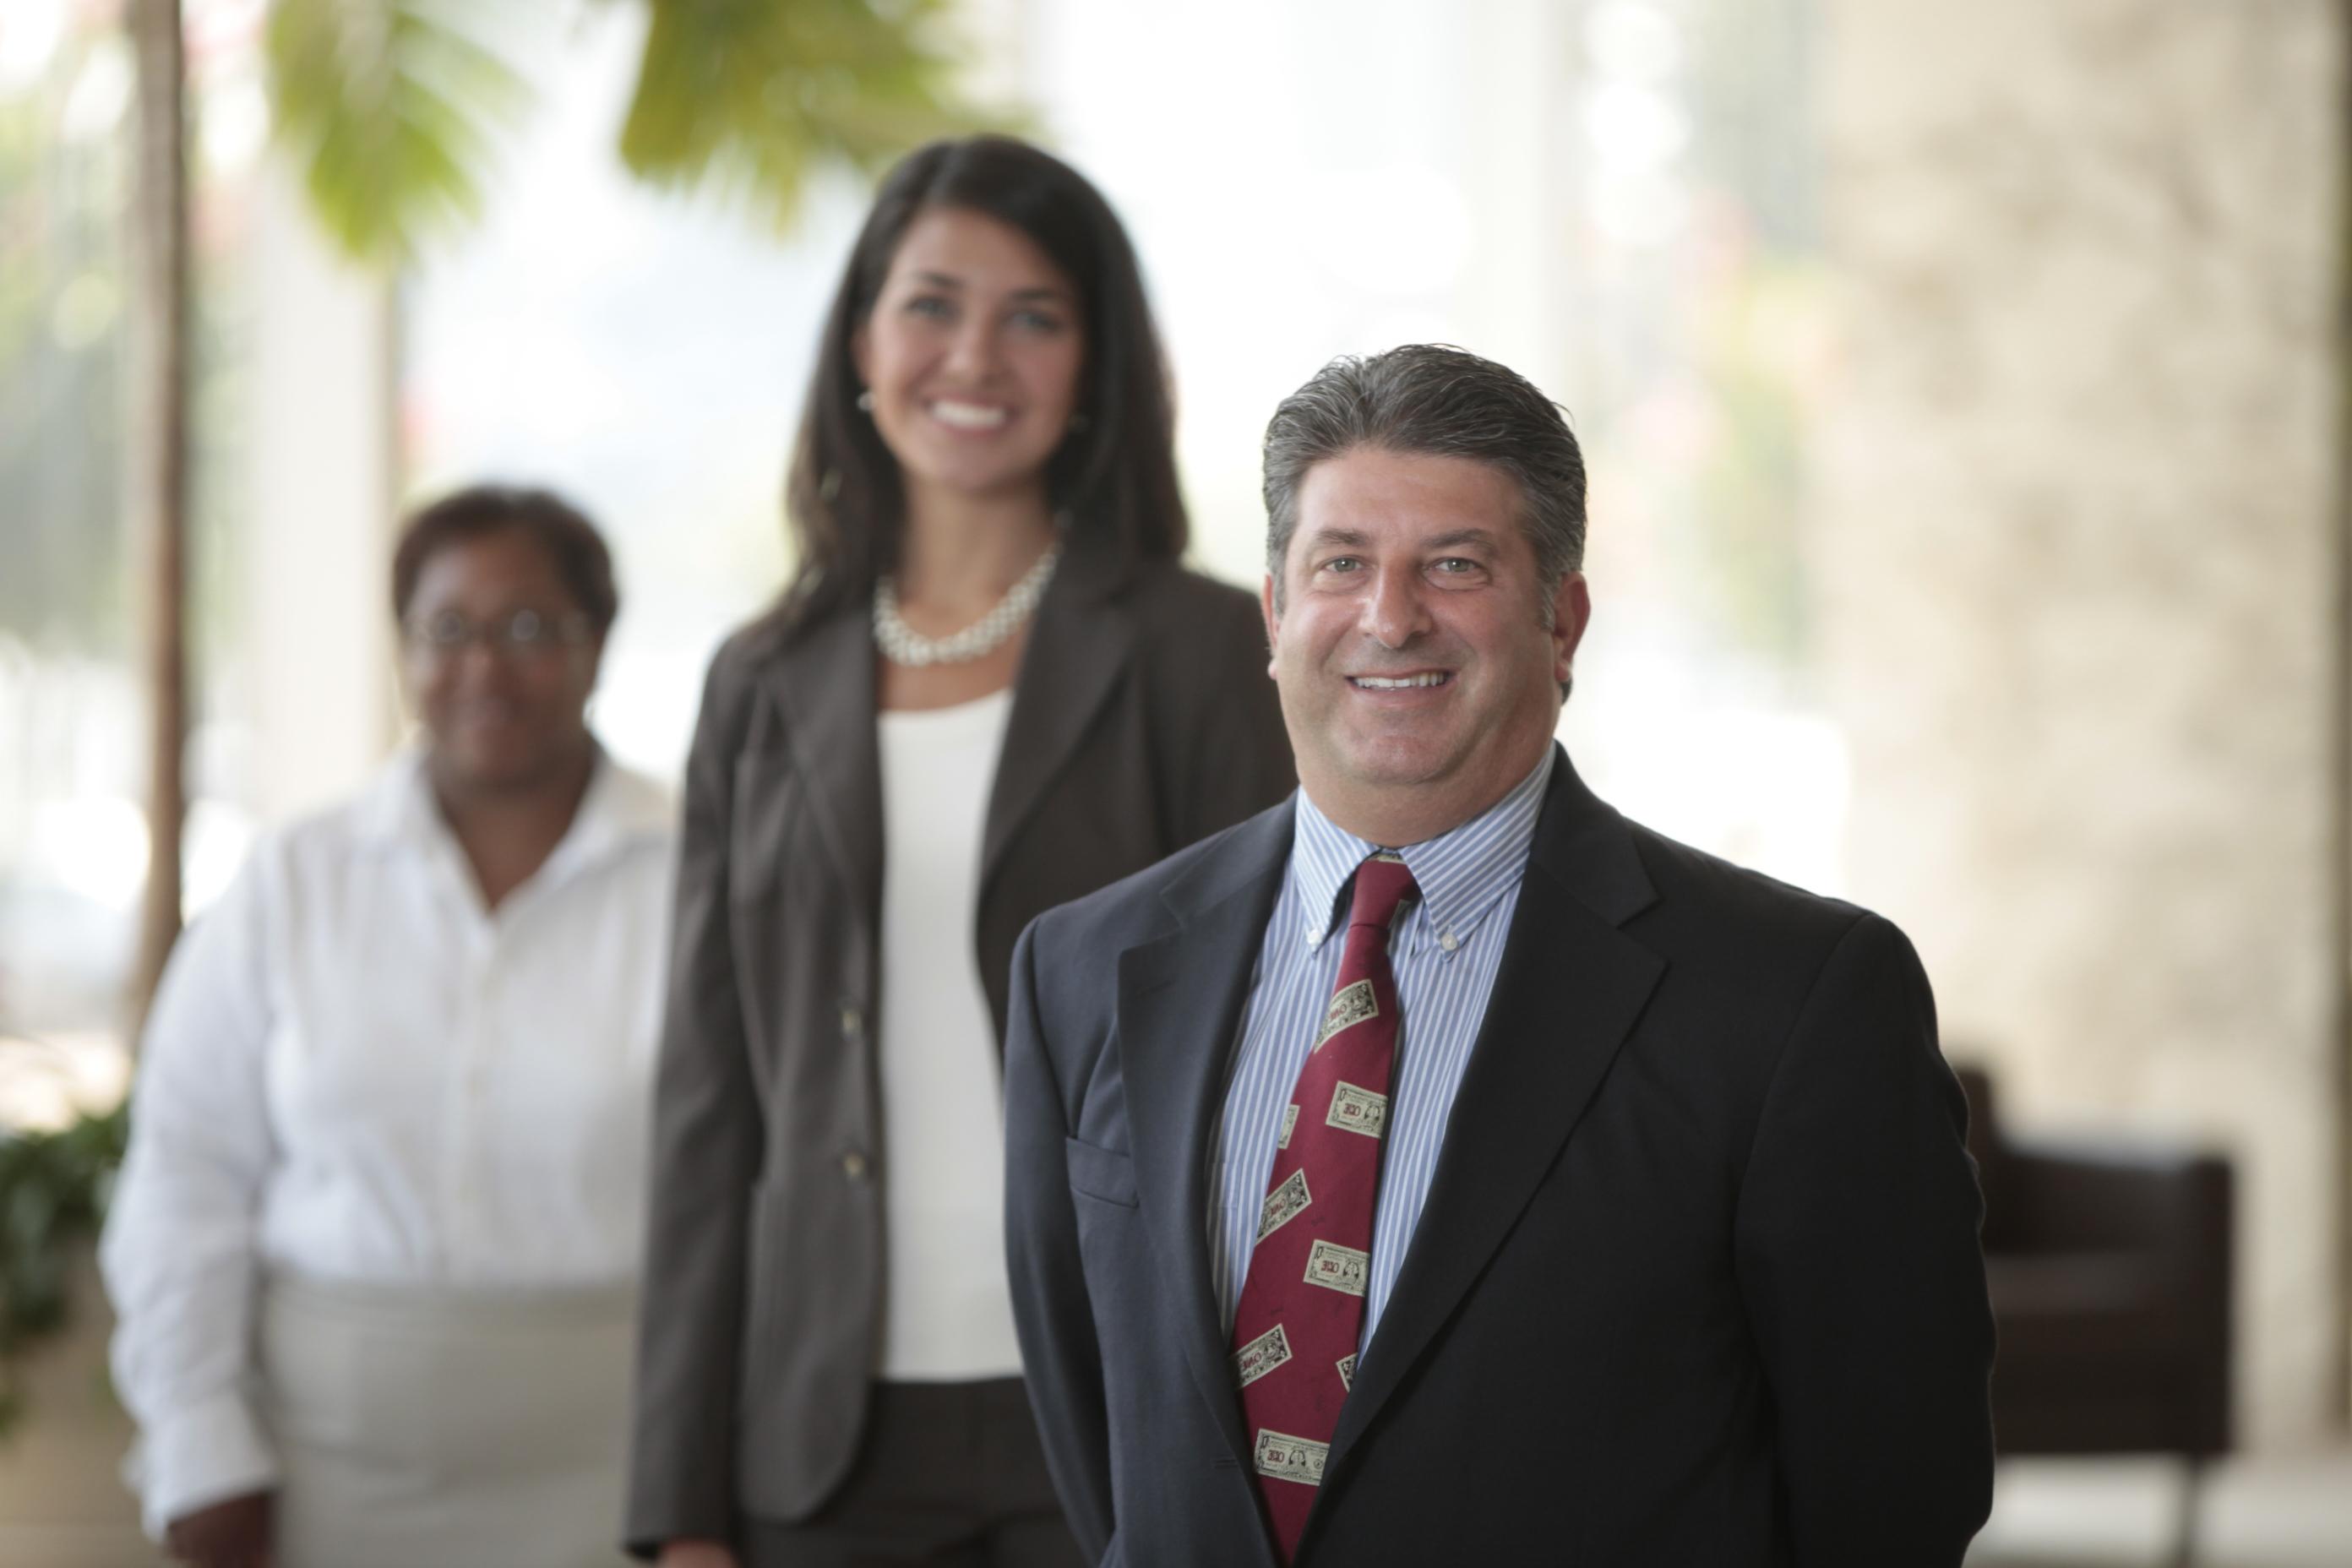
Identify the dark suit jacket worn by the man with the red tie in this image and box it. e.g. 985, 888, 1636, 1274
1004, 757, 1992, 1568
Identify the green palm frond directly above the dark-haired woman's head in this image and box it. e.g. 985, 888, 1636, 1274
621, 0, 990, 228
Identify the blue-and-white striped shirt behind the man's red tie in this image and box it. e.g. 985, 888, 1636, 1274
1206, 748, 1554, 1349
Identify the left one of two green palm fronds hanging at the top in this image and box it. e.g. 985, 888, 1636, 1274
266, 0, 529, 261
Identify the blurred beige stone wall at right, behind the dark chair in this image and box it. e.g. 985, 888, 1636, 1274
1809, 0, 2345, 1444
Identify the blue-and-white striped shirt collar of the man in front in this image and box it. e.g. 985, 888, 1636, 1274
1291, 745, 1560, 952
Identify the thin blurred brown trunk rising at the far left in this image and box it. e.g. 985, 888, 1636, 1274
129, 0, 188, 1030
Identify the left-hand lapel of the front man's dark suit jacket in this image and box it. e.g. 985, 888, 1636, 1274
1117, 804, 1291, 1467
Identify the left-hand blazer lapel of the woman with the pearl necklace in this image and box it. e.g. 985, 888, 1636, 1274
765, 611, 882, 928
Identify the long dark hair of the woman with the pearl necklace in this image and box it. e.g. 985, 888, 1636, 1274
783, 136, 1185, 625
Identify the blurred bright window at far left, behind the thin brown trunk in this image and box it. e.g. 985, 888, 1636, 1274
0, 0, 266, 1124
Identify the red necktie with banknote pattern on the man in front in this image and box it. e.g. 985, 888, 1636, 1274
1233, 853, 1416, 1563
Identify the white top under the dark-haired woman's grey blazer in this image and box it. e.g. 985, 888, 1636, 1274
875, 691, 1021, 1382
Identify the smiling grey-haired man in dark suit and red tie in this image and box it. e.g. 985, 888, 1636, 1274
1004, 348, 1992, 1568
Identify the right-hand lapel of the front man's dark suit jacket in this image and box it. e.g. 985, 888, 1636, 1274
1308, 754, 1665, 1485
